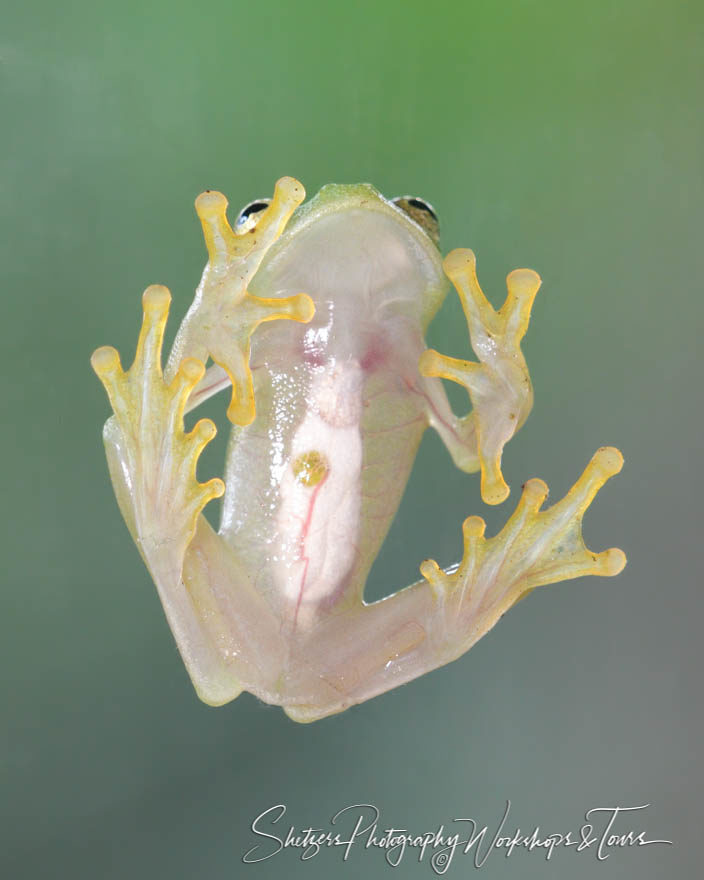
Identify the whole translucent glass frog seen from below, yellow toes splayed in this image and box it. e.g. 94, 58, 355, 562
92, 178, 625, 721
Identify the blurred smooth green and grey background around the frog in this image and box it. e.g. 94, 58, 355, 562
0, 0, 704, 880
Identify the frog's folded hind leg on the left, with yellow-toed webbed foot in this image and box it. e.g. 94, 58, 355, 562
92, 286, 280, 705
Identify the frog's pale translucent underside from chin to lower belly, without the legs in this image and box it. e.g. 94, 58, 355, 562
214, 187, 461, 624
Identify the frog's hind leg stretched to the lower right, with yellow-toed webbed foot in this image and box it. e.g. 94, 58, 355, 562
282, 447, 626, 721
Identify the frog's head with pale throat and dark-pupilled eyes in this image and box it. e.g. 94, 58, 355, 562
242, 183, 449, 331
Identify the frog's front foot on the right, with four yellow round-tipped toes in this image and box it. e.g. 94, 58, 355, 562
419, 249, 540, 504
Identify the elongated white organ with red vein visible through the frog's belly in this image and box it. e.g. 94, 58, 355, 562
275, 360, 364, 628
